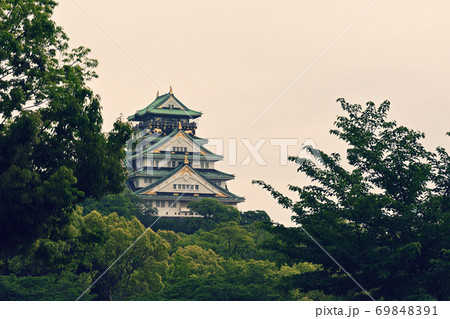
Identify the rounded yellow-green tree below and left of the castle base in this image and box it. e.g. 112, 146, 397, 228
78, 211, 169, 300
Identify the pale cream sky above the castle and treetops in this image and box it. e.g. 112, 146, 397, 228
54, 0, 450, 223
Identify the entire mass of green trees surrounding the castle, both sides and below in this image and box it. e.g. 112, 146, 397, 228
0, 0, 450, 300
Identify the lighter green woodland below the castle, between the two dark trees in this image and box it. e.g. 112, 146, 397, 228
0, 194, 324, 300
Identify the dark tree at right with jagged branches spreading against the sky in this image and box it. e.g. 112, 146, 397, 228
254, 99, 450, 300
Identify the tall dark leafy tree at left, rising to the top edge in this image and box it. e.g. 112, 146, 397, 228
0, 0, 131, 256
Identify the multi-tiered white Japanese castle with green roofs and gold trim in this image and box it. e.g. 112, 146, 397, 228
126, 87, 244, 217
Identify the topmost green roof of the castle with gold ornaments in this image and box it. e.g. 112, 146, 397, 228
128, 93, 202, 121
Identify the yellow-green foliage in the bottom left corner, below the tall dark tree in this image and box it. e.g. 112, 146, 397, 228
0, 211, 169, 300
